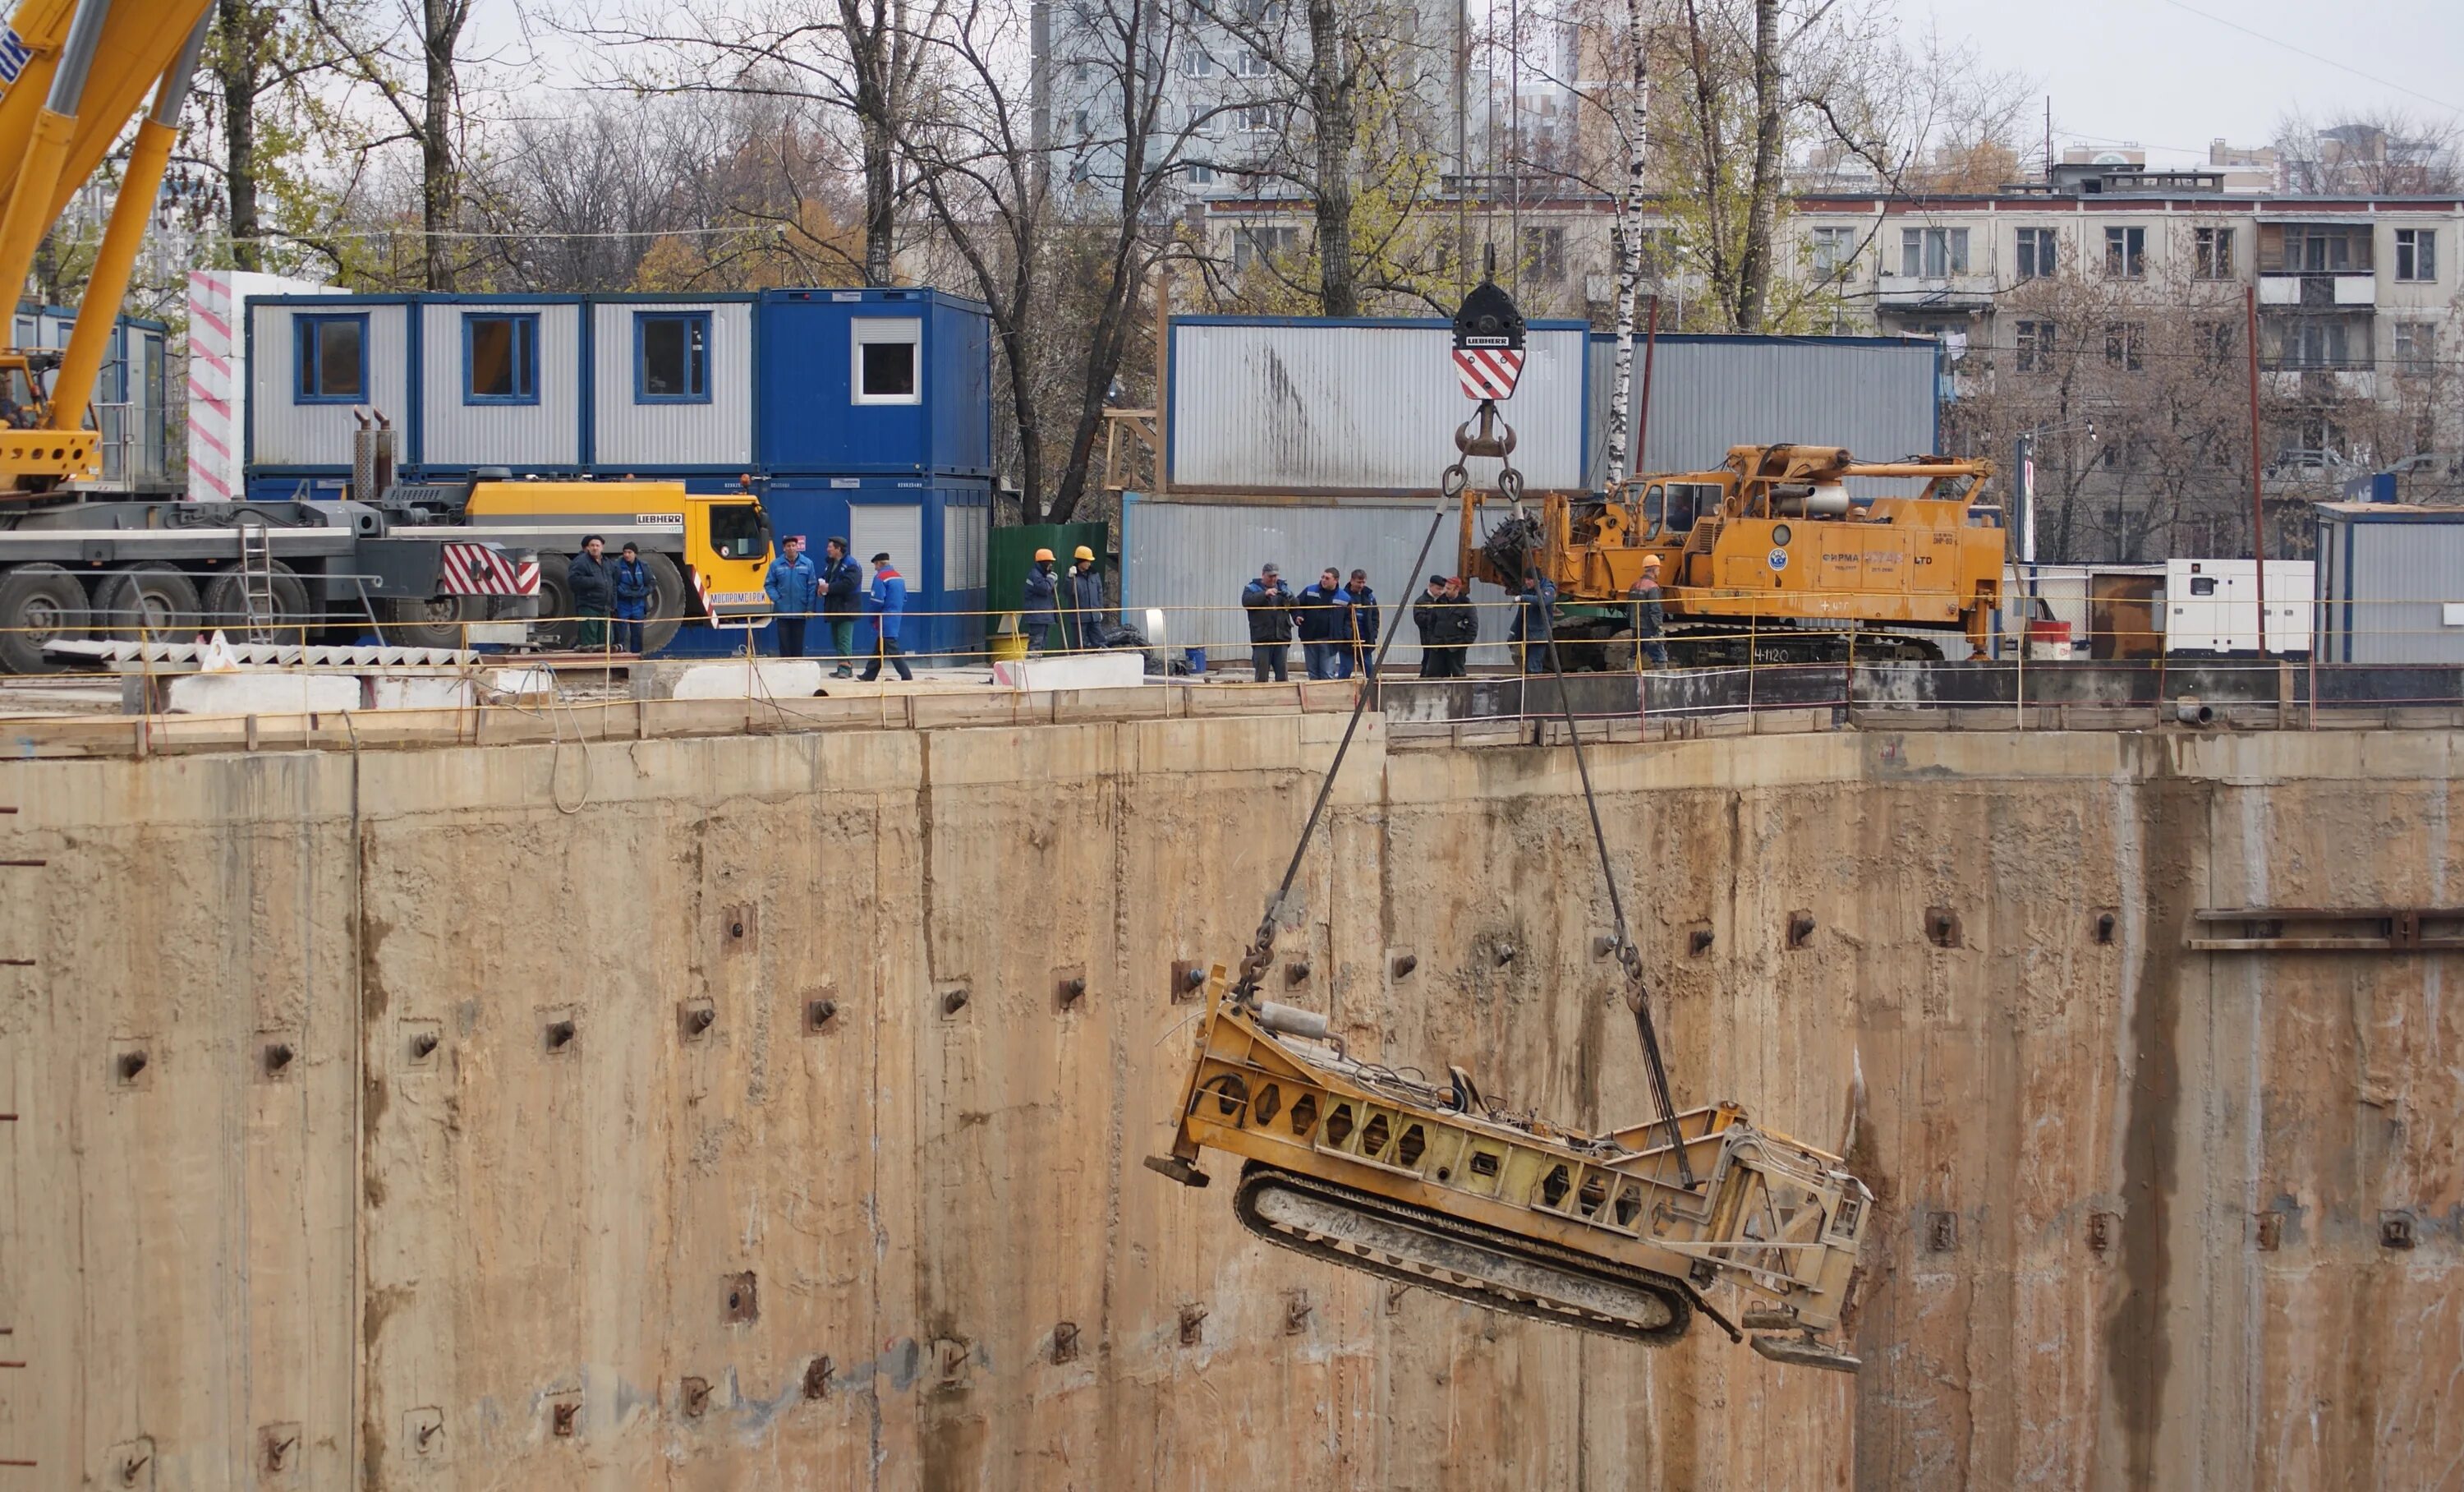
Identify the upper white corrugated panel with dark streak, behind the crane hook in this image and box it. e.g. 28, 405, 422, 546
1170, 318, 1587, 493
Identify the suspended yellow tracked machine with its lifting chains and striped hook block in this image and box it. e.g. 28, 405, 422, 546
1146, 269, 1873, 1371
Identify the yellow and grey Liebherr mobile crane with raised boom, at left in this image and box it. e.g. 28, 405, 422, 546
0, 0, 771, 673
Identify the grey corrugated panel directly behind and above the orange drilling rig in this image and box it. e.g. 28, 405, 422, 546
1584, 335, 1939, 495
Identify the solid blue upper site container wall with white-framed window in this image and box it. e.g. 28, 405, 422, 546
754, 288, 993, 476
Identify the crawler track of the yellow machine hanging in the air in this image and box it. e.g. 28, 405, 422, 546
1232, 1162, 1693, 1347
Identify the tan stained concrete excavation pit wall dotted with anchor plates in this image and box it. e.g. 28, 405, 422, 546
0, 700, 2464, 1490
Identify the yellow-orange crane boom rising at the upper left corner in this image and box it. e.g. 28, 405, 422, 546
0, 0, 212, 498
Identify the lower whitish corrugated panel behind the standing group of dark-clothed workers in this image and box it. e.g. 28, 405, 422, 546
1121, 495, 1513, 668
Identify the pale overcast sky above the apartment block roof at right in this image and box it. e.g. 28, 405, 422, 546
1897, 0, 2464, 165
